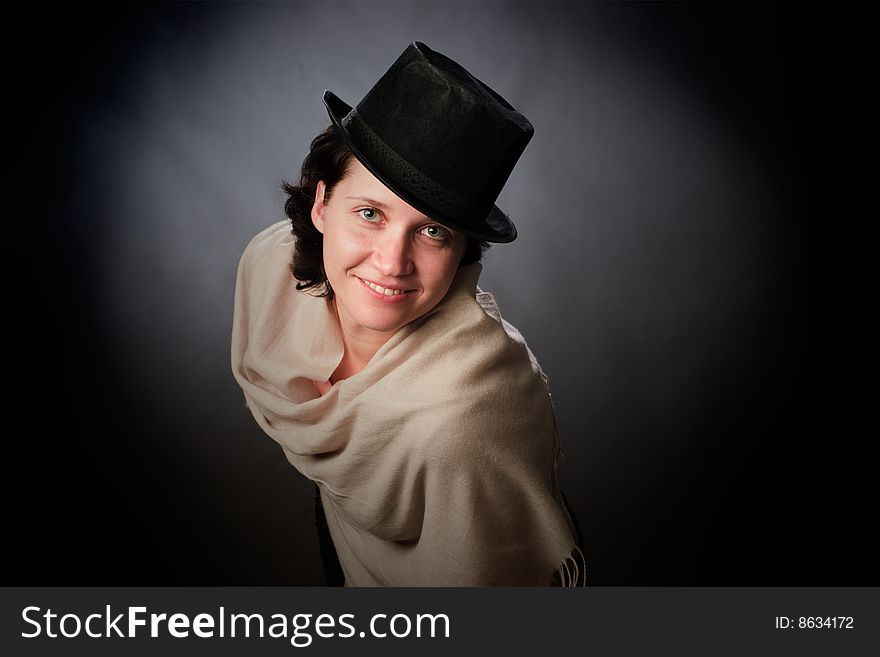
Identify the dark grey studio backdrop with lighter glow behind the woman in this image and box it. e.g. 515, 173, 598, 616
0, 2, 880, 585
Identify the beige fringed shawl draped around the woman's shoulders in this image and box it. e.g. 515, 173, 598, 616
232, 222, 583, 586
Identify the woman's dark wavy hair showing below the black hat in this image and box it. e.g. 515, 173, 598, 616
281, 125, 489, 299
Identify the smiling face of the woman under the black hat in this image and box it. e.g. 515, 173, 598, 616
312, 158, 466, 341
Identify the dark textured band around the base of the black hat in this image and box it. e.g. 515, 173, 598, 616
342, 109, 493, 233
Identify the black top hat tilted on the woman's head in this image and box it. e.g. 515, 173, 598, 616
324, 41, 535, 242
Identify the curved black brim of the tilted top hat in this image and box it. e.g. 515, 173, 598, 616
324, 91, 517, 244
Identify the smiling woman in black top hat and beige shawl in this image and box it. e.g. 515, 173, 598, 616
232, 43, 584, 586
